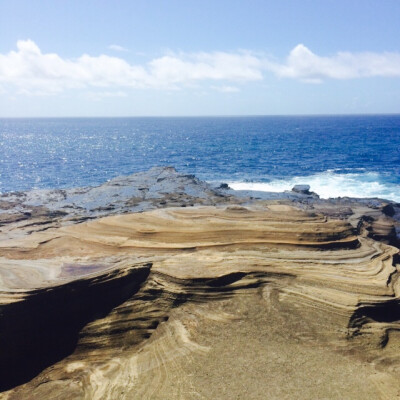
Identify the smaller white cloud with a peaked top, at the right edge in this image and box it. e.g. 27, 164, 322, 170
267, 44, 400, 83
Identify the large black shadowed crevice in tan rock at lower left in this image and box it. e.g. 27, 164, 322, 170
0, 264, 151, 391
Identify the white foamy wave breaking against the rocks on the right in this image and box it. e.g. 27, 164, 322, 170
228, 170, 400, 202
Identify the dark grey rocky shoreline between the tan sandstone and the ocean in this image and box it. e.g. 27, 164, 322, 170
0, 167, 400, 245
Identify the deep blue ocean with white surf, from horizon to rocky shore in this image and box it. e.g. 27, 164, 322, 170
0, 115, 400, 202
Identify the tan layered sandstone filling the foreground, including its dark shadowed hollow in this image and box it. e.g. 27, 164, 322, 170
0, 202, 400, 400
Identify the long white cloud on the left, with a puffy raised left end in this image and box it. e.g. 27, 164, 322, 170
0, 40, 262, 94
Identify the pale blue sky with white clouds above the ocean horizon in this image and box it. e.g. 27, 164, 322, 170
0, 0, 400, 117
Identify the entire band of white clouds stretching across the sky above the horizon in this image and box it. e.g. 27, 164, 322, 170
0, 39, 400, 95
